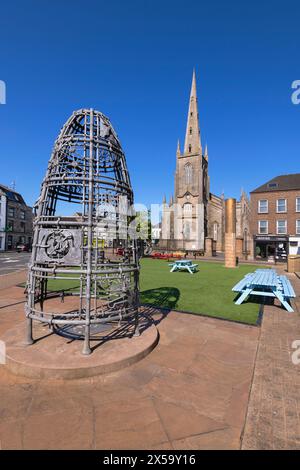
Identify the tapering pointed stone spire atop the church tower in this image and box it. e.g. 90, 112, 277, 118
184, 69, 202, 155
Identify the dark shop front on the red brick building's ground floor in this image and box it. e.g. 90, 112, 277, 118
254, 235, 289, 262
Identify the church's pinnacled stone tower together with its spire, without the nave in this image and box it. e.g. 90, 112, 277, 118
161, 71, 209, 250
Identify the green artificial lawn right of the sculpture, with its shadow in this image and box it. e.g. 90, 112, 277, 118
140, 258, 259, 324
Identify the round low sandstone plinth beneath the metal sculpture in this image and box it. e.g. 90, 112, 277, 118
1, 322, 159, 379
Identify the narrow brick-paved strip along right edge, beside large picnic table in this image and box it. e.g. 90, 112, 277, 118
242, 273, 300, 450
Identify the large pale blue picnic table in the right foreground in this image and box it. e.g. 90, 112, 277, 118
232, 269, 296, 312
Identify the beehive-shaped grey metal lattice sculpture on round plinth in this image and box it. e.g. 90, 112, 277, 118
25, 109, 139, 354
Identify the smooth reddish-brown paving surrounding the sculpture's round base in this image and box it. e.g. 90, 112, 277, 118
0, 278, 259, 450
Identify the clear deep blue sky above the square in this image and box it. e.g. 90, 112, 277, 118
0, 0, 300, 204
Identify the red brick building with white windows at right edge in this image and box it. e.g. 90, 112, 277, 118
250, 173, 300, 261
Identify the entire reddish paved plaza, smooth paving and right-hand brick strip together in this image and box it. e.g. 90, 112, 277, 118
0, 266, 300, 450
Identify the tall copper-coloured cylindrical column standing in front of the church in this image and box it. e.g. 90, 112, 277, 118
225, 199, 236, 268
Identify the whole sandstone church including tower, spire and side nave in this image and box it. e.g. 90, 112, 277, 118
159, 71, 250, 255
